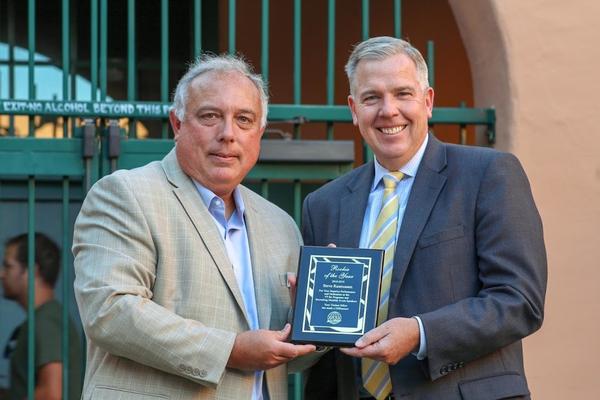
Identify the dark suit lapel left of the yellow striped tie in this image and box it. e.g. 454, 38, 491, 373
336, 162, 375, 247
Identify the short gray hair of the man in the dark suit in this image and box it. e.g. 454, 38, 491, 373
346, 36, 429, 93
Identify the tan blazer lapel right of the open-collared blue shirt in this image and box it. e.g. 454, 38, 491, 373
240, 186, 277, 329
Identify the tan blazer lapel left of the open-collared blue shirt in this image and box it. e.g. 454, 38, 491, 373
161, 149, 249, 326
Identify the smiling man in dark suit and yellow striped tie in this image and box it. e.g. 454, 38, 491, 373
302, 37, 546, 400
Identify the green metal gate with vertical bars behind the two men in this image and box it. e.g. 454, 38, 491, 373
0, 0, 495, 399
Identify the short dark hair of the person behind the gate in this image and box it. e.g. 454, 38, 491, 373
4, 233, 60, 287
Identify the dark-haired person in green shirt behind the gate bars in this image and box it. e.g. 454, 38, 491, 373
0, 233, 82, 400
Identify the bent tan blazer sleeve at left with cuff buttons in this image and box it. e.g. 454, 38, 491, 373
73, 173, 235, 387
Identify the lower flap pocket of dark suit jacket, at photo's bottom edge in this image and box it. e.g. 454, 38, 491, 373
458, 372, 529, 400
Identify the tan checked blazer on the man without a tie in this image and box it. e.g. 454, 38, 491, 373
73, 151, 308, 400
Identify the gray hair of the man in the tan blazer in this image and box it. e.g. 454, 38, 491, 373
171, 53, 269, 128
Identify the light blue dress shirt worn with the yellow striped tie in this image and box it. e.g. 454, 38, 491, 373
359, 136, 429, 360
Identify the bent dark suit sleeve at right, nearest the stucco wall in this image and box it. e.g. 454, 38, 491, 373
419, 153, 547, 379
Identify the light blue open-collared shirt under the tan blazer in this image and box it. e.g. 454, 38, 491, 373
194, 181, 268, 400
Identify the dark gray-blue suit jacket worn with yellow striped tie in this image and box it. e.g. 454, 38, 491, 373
302, 136, 546, 400
